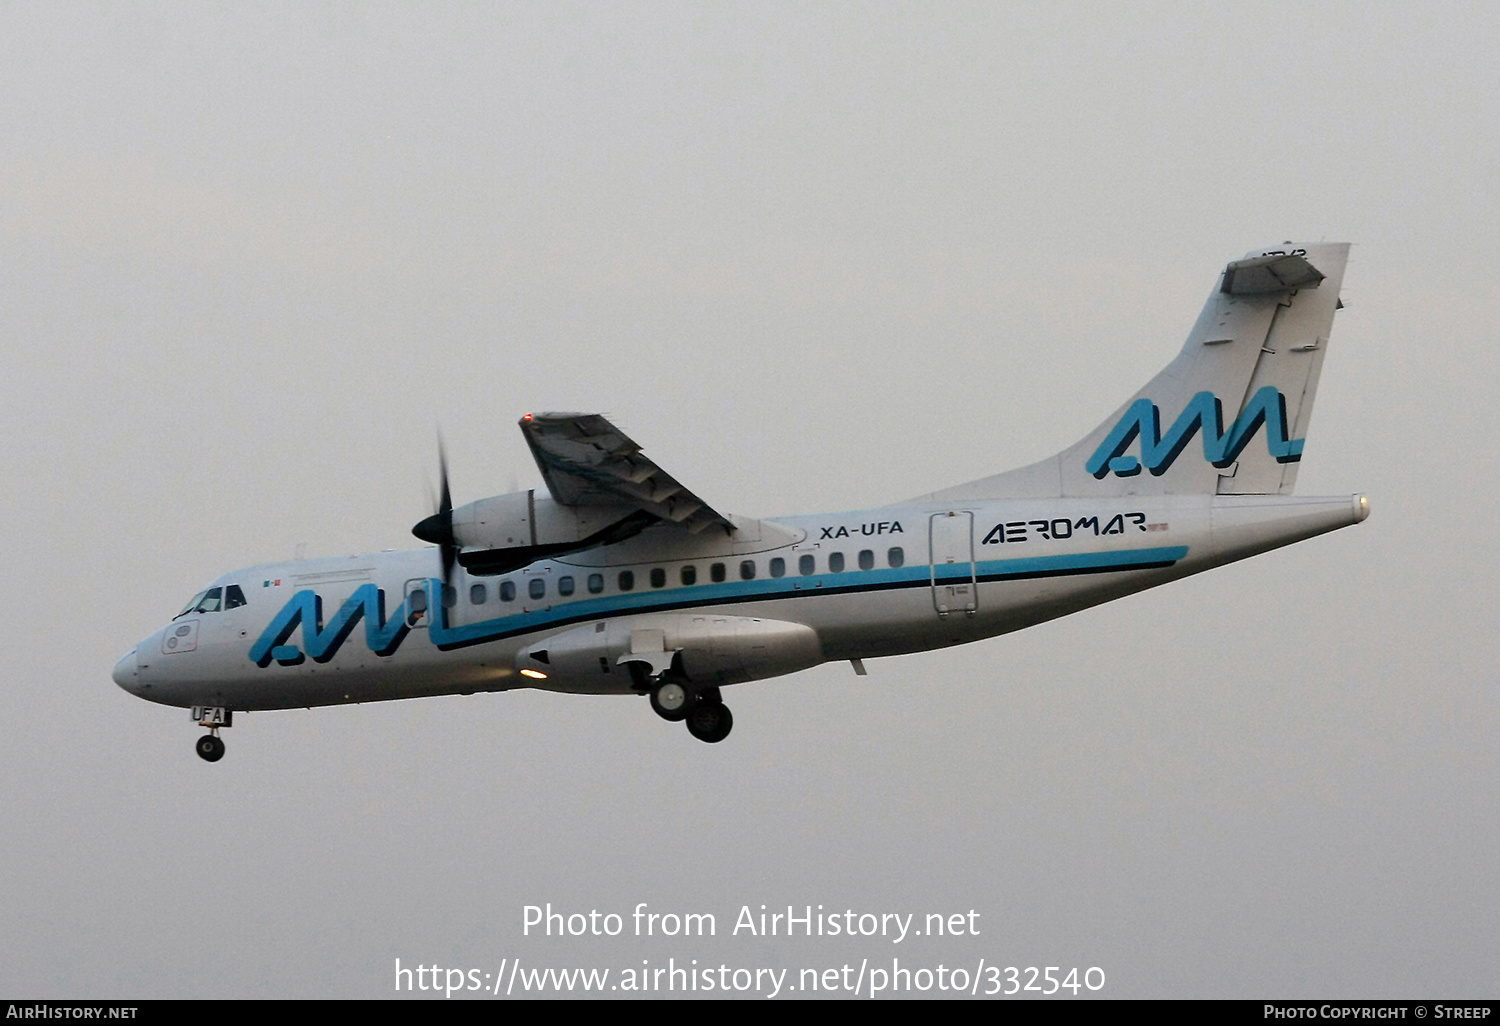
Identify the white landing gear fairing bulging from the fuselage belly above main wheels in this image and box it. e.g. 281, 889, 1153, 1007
516, 614, 824, 692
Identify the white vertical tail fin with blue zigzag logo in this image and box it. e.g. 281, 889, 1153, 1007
932, 243, 1349, 500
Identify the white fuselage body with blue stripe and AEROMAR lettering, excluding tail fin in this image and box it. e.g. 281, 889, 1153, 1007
114, 495, 1367, 711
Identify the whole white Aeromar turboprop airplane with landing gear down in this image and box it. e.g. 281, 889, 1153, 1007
113, 243, 1370, 762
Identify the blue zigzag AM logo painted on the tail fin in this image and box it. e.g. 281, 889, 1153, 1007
1085, 386, 1304, 480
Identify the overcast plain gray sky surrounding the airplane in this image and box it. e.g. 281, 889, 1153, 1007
0, 3, 1500, 998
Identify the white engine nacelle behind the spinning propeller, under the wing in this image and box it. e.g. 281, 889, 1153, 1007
452, 489, 656, 573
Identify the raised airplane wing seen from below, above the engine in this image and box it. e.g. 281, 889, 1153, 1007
521, 413, 734, 534
